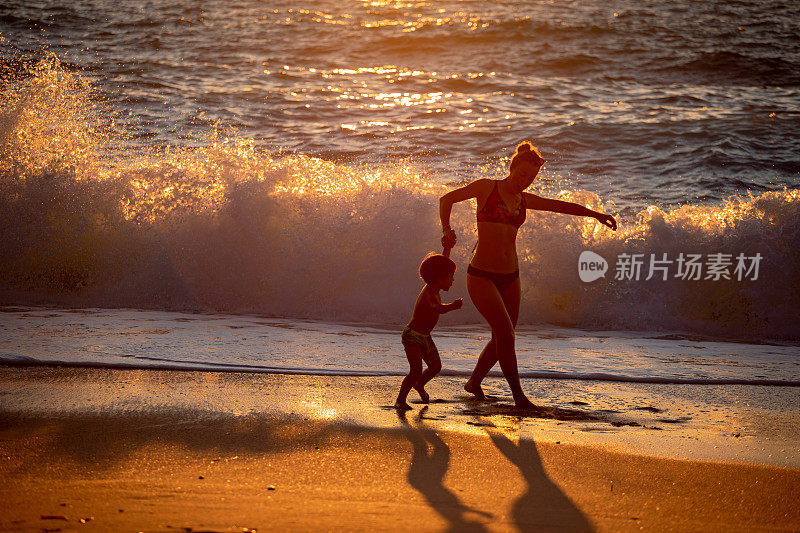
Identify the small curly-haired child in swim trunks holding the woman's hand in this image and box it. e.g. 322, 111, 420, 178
394, 254, 463, 410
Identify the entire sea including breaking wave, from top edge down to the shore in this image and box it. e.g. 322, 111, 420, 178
0, 0, 800, 372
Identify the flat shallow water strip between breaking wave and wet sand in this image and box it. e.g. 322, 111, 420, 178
0, 306, 800, 384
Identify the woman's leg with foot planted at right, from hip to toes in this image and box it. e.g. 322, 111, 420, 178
467, 276, 535, 408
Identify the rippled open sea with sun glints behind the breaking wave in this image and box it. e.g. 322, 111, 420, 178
0, 0, 800, 195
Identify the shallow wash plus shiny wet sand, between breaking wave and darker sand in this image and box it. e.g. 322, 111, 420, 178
6, 306, 800, 468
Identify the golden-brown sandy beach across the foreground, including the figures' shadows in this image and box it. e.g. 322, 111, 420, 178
0, 367, 800, 531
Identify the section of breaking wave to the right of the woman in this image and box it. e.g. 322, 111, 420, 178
522, 189, 800, 340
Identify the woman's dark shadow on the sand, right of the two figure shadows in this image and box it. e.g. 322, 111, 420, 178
482, 422, 593, 531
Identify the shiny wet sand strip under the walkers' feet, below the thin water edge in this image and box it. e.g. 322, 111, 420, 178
0, 365, 800, 468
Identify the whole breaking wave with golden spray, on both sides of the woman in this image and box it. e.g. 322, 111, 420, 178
0, 55, 800, 339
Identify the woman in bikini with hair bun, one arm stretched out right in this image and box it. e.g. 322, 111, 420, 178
439, 141, 617, 409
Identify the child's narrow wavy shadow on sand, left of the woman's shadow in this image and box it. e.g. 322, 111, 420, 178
398, 407, 491, 532
